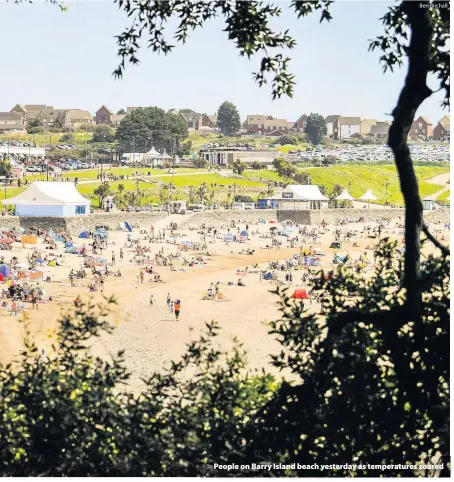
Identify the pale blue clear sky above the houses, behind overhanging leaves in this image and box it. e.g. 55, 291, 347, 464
0, 0, 448, 124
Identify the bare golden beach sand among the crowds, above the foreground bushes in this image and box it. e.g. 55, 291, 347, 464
0, 213, 449, 390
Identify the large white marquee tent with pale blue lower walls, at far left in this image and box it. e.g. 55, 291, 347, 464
4, 181, 90, 218
